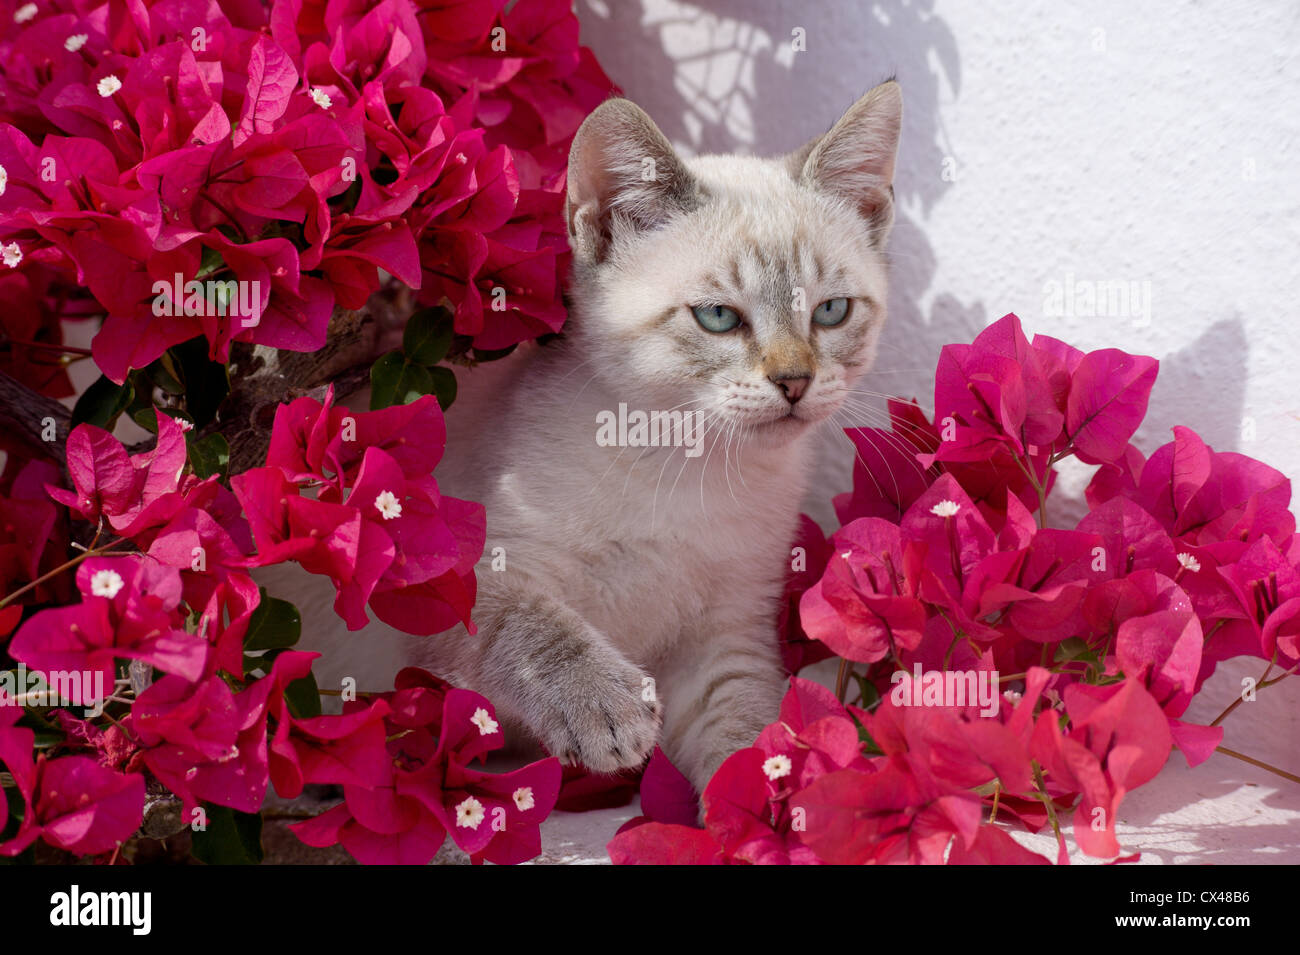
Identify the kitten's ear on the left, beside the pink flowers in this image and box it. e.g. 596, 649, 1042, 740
564, 99, 699, 262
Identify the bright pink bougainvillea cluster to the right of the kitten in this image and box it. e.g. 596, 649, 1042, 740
610, 314, 1300, 864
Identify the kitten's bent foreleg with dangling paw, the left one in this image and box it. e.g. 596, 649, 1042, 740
431, 589, 663, 773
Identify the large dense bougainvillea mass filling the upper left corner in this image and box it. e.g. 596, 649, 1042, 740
0, 0, 611, 384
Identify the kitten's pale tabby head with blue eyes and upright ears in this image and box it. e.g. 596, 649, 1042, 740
566, 81, 902, 444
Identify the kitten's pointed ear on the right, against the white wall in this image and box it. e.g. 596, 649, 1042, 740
785, 79, 902, 247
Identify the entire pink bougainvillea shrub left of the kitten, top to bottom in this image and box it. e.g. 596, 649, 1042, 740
0, 0, 612, 863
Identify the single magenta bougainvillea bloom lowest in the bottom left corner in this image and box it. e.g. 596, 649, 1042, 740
35, 756, 144, 855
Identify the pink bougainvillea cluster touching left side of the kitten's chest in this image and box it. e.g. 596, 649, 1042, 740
244, 392, 486, 634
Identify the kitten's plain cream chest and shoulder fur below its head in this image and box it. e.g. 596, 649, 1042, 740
437, 348, 806, 664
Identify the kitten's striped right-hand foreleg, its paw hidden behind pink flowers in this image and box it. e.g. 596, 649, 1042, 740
657, 615, 788, 793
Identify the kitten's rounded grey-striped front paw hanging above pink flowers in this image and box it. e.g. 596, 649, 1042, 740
541, 660, 663, 773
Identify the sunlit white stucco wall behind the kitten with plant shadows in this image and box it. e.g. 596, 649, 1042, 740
577, 0, 1300, 522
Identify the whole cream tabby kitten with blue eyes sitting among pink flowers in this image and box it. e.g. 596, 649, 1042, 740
272, 82, 902, 791
